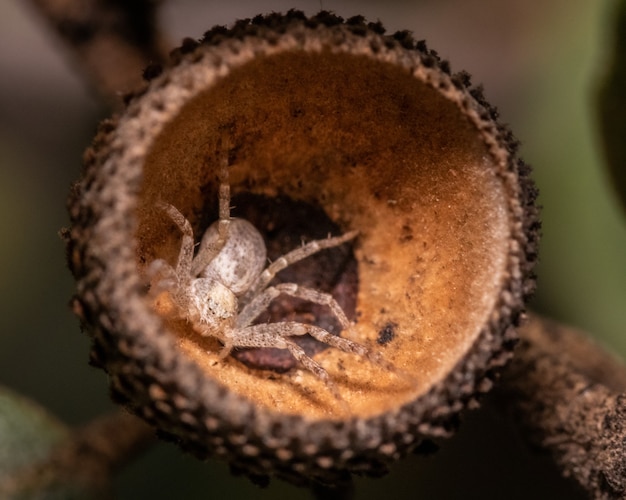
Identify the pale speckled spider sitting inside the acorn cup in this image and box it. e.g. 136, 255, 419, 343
148, 145, 395, 401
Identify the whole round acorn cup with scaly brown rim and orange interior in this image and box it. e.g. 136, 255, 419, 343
68, 11, 539, 484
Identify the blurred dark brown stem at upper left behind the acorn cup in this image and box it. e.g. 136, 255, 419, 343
31, 0, 166, 104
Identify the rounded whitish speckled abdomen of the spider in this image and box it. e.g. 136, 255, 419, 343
199, 218, 267, 296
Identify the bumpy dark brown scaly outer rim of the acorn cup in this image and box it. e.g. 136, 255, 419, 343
68, 12, 539, 482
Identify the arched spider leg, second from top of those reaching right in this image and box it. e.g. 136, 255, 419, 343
236, 283, 350, 330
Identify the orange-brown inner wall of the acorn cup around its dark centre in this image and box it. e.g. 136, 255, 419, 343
137, 52, 509, 419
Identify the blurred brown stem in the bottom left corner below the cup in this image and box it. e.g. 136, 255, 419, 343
0, 410, 155, 494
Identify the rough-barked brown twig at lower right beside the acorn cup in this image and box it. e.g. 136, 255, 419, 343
504, 316, 626, 498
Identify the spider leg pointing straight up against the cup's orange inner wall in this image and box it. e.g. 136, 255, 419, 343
191, 134, 230, 277
